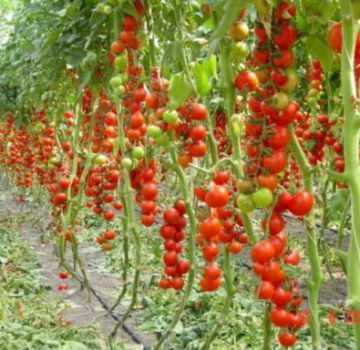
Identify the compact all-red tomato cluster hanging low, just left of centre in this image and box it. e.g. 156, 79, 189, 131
159, 200, 190, 290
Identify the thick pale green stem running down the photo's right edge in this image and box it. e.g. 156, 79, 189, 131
340, 0, 360, 349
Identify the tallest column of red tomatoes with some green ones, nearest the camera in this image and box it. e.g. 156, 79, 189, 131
235, 1, 314, 347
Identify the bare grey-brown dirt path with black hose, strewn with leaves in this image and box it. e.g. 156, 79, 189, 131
0, 185, 154, 350
